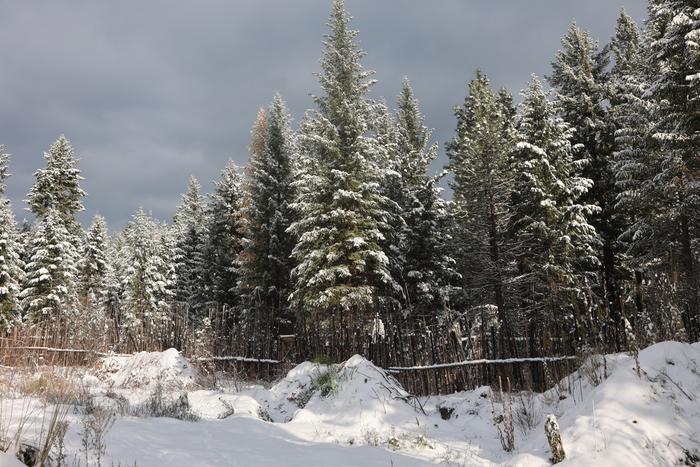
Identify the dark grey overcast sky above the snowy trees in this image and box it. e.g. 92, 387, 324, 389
0, 0, 645, 228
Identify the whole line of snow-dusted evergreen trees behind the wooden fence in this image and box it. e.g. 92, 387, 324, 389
0, 0, 700, 356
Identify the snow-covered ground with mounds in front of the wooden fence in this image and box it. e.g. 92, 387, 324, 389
0, 342, 700, 467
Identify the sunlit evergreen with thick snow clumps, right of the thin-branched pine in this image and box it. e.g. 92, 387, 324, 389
511, 76, 599, 344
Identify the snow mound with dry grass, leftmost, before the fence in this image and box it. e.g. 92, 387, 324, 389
96, 349, 198, 391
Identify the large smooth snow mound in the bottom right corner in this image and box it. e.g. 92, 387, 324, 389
513, 342, 700, 466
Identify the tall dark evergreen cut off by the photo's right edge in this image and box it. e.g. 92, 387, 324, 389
644, 0, 700, 340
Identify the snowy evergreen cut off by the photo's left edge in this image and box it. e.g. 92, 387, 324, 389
0, 145, 23, 332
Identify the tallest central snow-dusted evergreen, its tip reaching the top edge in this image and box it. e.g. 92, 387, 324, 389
291, 0, 396, 326
